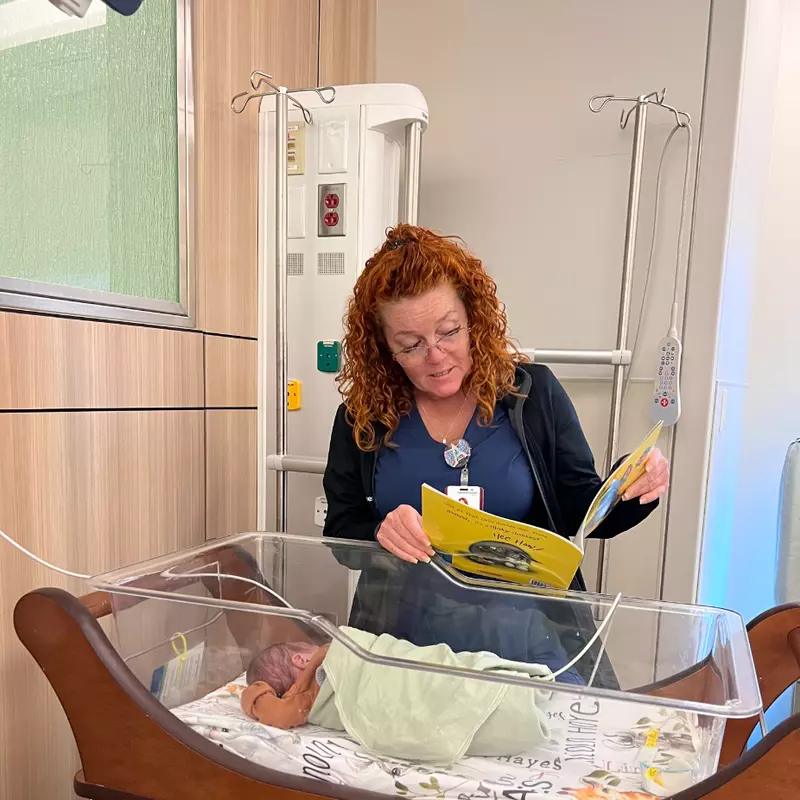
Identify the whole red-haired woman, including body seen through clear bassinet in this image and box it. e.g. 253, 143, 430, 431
323, 225, 669, 688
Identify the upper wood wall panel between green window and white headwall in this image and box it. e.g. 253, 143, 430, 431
195, 0, 319, 337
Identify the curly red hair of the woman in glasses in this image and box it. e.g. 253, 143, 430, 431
337, 225, 522, 451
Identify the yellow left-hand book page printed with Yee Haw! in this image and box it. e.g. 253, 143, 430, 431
422, 484, 583, 589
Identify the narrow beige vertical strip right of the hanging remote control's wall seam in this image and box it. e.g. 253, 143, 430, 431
661, 0, 748, 602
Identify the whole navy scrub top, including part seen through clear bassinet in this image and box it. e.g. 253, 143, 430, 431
368, 407, 583, 685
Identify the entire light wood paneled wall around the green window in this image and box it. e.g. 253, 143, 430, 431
0, 0, 374, 800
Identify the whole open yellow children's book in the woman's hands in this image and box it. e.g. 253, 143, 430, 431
422, 422, 661, 589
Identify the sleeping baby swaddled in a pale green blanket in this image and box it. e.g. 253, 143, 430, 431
242, 628, 572, 765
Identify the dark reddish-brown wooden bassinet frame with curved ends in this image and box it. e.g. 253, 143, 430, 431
14, 546, 800, 800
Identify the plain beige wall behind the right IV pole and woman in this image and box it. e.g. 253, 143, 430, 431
376, 0, 712, 600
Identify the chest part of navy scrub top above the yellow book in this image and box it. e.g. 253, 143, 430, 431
375, 406, 534, 521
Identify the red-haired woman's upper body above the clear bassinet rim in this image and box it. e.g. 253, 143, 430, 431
324, 225, 669, 576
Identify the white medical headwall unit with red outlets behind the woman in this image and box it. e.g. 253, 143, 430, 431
233, 73, 428, 580
